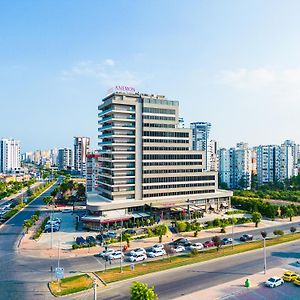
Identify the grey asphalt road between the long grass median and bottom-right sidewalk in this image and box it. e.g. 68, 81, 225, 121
101, 241, 300, 300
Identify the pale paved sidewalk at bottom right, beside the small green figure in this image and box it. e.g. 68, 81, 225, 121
175, 268, 286, 300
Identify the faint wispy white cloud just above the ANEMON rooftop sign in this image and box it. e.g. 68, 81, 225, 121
61, 59, 142, 88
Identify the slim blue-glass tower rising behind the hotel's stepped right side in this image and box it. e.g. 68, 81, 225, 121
190, 122, 211, 170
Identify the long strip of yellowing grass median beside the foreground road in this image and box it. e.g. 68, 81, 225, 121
96, 233, 300, 283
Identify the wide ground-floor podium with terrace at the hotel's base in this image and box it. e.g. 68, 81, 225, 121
81, 190, 232, 231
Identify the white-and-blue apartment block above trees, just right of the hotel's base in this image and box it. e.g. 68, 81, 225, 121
219, 143, 252, 189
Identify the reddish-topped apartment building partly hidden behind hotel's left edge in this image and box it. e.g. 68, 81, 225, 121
86, 153, 101, 193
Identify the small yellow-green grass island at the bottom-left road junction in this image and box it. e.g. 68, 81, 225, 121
49, 274, 93, 296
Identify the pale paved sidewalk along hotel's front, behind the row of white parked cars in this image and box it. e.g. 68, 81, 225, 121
19, 214, 300, 258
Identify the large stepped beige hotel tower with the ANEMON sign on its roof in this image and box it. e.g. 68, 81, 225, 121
82, 92, 232, 230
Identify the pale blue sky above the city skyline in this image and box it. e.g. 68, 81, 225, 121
0, 0, 300, 151
